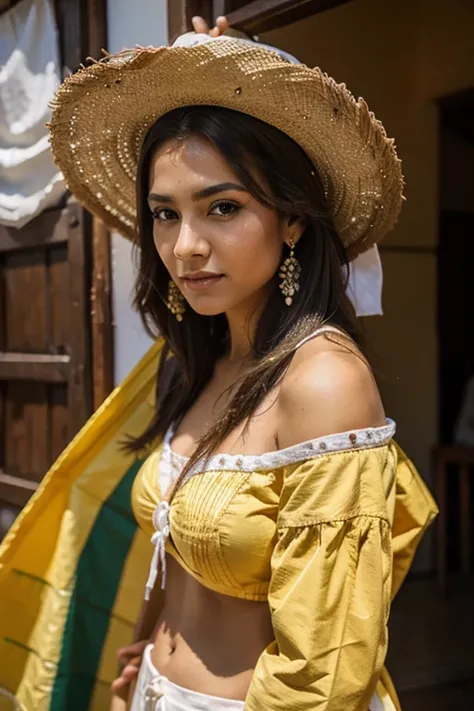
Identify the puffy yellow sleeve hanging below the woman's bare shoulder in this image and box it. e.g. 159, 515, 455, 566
245, 444, 397, 711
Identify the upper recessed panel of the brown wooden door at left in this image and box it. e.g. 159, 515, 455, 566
4, 248, 48, 353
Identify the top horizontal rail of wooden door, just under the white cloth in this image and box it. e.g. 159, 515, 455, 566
0, 209, 68, 252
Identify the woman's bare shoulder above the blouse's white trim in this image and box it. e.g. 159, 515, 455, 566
277, 335, 385, 448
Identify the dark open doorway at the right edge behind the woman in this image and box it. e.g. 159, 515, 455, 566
438, 88, 474, 571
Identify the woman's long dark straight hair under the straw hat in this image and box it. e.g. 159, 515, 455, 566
129, 106, 357, 490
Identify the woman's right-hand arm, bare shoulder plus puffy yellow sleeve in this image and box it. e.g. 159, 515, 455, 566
246, 344, 396, 711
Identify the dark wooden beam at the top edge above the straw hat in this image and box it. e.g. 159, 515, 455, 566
222, 0, 353, 34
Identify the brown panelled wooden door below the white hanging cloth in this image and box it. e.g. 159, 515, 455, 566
0, 203, 92, 531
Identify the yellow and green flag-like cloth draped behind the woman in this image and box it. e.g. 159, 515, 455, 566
0, 340, 163, 711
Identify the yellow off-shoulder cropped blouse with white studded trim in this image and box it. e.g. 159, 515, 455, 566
132, 423, 437, 711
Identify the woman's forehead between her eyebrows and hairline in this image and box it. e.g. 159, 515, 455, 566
150, 136, 236, 187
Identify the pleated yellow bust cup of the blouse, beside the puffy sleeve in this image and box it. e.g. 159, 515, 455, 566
167, 469, 281, 600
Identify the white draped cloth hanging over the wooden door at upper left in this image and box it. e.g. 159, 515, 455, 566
0, 0, 66, 228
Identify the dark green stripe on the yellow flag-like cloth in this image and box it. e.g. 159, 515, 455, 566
50, 461, 142, 711
